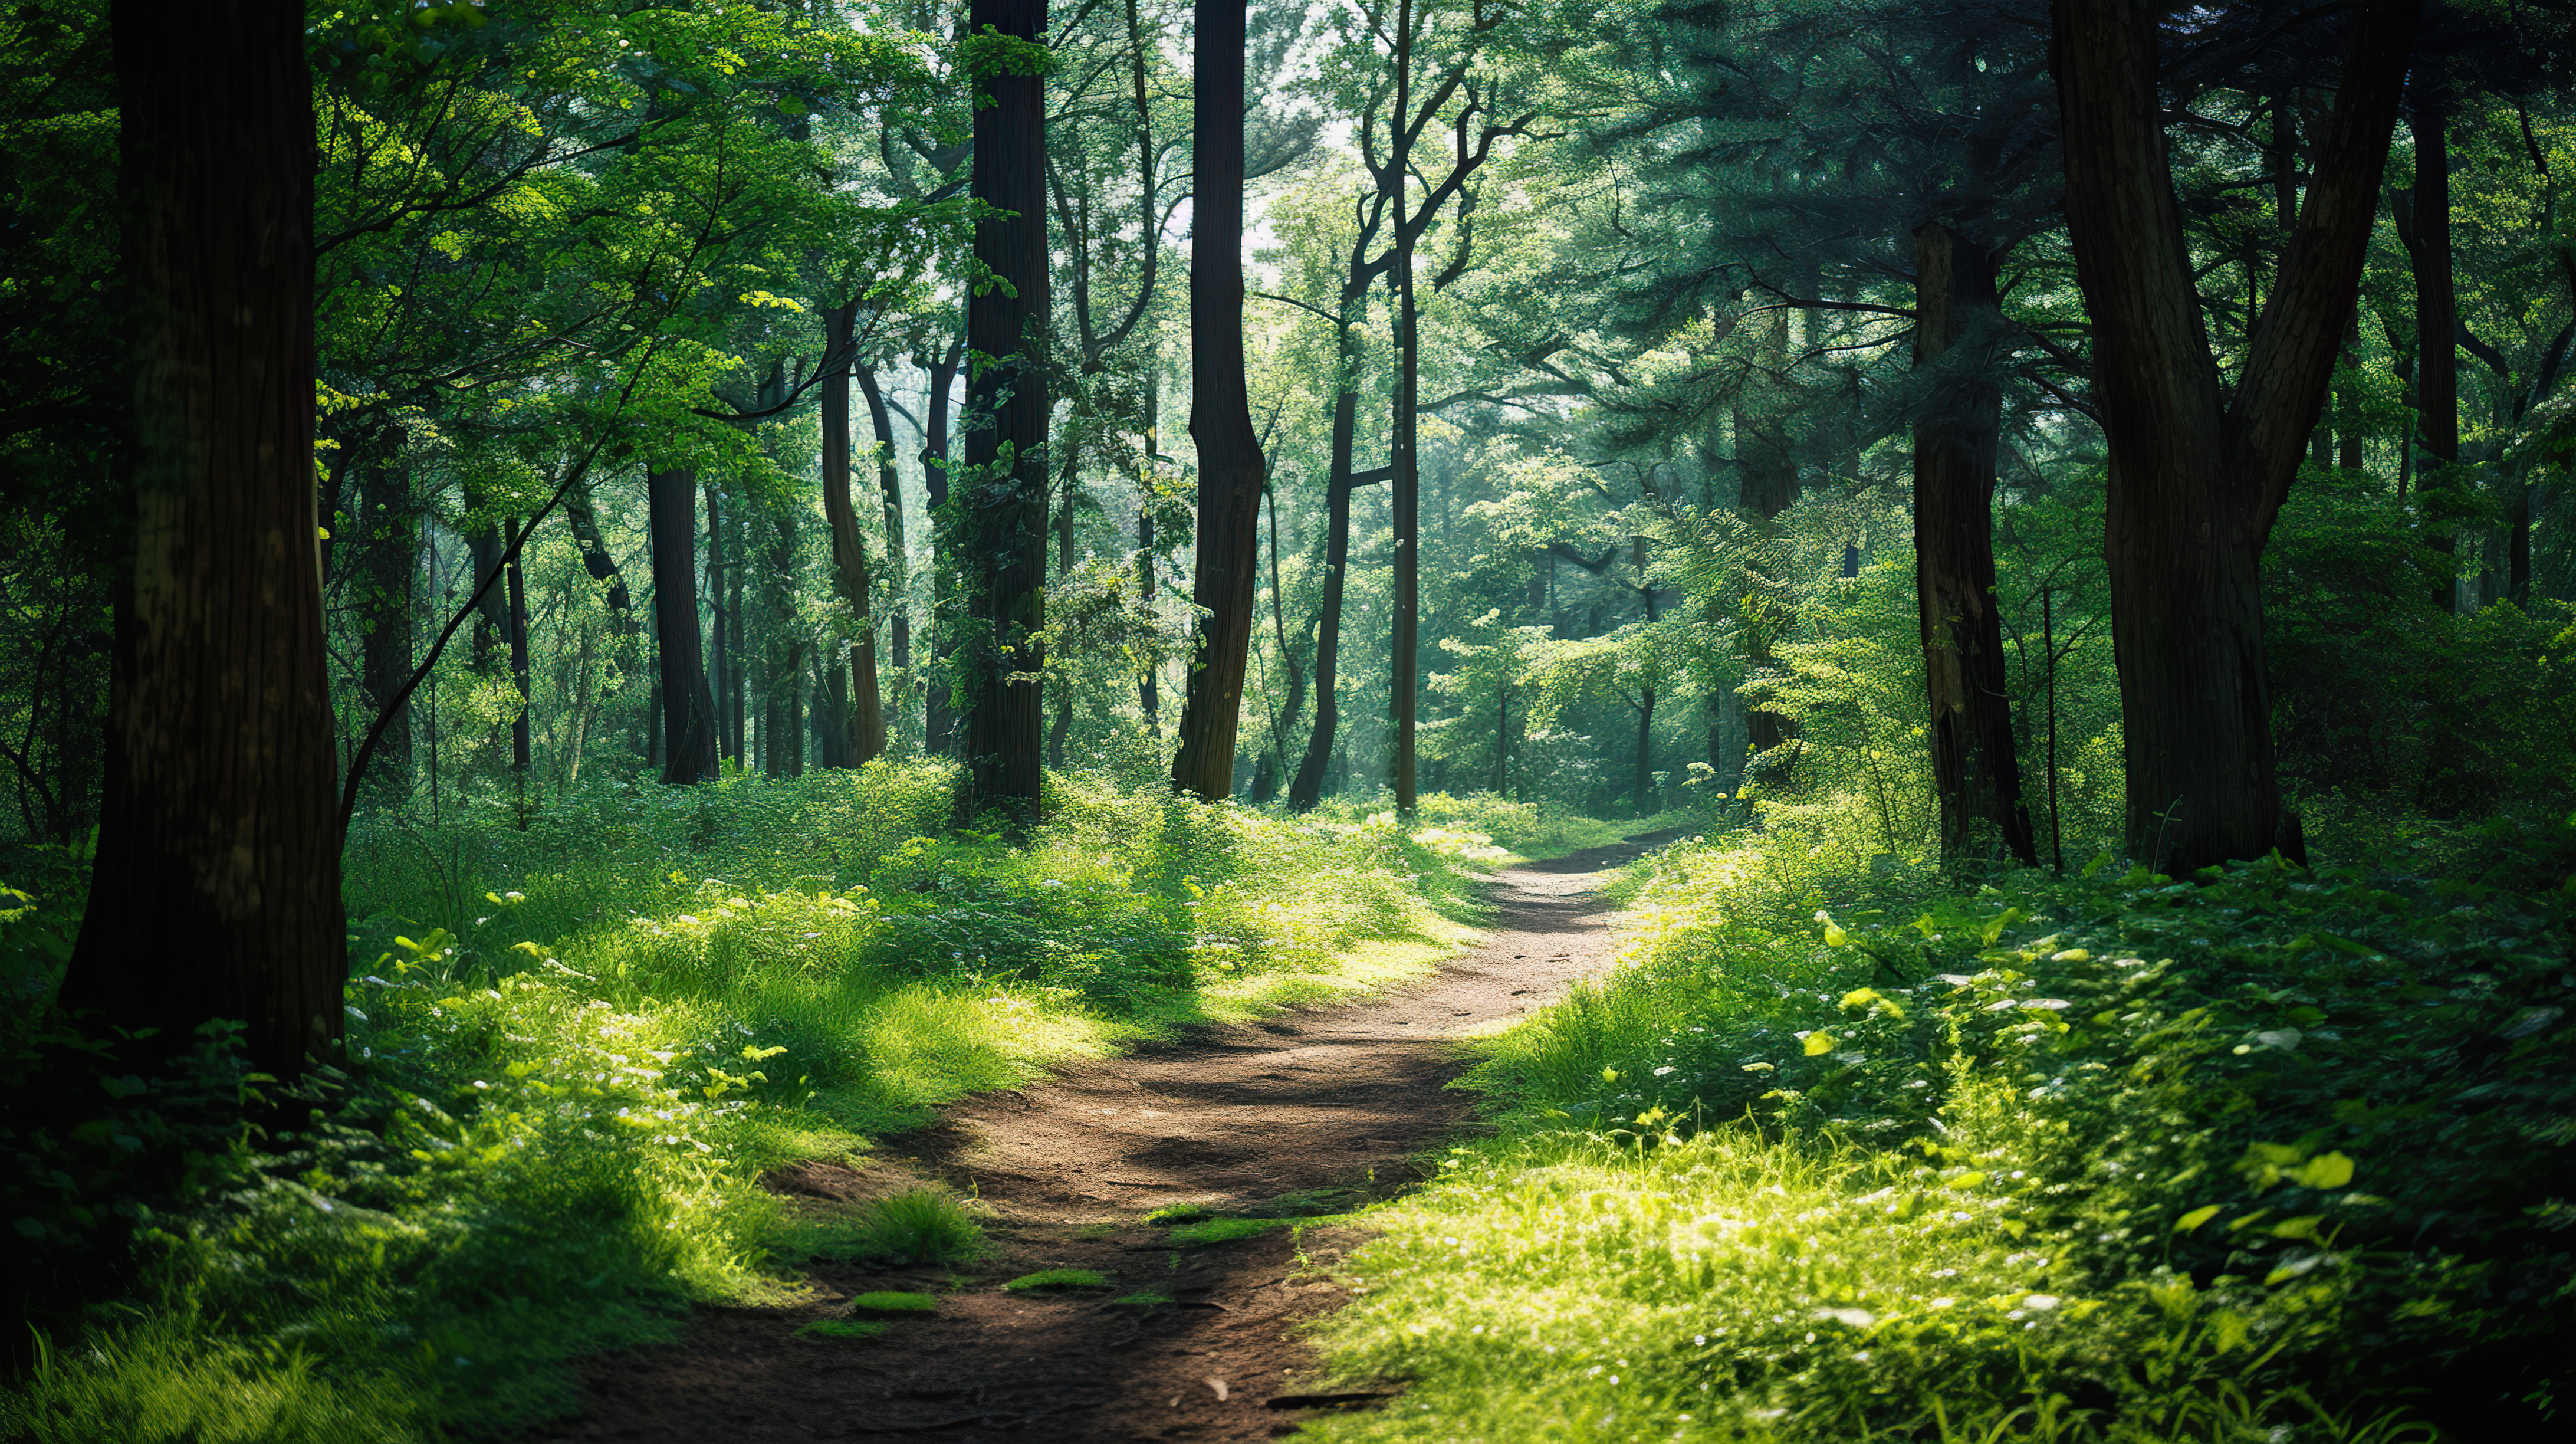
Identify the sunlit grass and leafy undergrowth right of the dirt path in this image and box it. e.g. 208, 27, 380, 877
1316, 820, 2576, 1444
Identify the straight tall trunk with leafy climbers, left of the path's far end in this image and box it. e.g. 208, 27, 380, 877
958, 0, 1049, 820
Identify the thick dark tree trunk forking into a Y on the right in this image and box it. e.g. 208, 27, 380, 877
2051, 0, 2416, 874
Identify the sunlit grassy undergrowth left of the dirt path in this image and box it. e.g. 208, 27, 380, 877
0, 766, 1484, 1444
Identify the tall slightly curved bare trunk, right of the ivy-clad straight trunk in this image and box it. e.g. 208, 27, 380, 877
1172, 0, 1277, 802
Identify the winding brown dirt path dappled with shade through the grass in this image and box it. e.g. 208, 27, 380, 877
533, 835, 1664, 1444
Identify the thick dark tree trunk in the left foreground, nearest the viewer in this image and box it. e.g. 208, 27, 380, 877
62, 0, 348, 1078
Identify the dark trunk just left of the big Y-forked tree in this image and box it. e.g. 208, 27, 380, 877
1914, 222, 2038, 867
